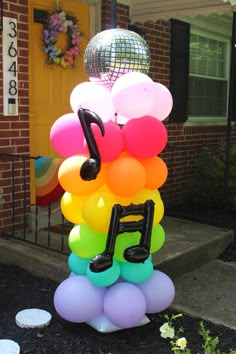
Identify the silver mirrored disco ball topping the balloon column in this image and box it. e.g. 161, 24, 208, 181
84, 28, 150, 88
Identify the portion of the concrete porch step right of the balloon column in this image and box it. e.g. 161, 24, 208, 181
153, 217, 234, 279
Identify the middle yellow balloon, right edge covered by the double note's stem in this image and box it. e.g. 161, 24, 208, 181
83, 190, 118, 232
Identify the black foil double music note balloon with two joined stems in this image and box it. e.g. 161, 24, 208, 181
90, 200, 154, 273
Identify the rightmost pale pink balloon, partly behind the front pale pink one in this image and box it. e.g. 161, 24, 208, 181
148, 82, 173, 120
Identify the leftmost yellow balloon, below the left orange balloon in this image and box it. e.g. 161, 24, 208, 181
61, 192, 88, 224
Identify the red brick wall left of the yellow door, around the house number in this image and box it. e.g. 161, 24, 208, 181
0, 0, 29, 231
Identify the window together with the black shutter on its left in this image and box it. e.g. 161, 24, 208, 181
169, 13, 236, 126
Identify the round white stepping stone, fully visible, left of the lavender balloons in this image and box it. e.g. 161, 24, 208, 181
15, 309, 52, 330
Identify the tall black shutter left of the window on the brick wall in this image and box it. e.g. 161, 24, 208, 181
169, 19, 190, 122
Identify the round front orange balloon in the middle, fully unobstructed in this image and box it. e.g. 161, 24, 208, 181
107, 156, 146, 197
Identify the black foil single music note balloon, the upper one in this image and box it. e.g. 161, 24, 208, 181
78, 108, 105, 181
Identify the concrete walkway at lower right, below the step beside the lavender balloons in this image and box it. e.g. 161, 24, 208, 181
171, 260, 236, 330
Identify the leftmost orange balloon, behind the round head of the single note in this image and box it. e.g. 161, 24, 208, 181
58, 155, 106, 194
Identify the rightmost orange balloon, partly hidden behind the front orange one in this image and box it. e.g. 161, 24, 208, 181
139, 156, 168, 190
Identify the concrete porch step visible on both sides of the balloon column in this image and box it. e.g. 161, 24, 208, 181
0, 217, 234, 281
